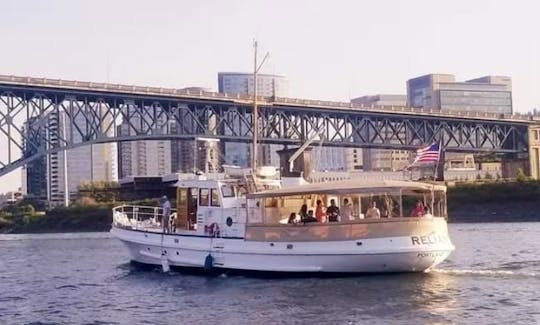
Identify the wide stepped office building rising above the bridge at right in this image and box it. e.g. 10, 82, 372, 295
407, 74, 513, 114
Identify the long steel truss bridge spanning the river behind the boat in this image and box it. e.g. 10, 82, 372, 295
0, 76, 536, 176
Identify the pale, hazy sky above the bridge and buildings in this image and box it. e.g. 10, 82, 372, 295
0, 0, 540, 192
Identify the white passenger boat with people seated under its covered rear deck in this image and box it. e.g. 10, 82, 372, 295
111, 177, 454, 274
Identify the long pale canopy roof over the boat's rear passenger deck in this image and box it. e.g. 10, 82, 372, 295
248, 179, 446, 199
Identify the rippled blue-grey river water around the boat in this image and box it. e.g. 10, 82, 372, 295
0, 223, 540, 325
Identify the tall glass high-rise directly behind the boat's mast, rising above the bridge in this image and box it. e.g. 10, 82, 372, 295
218, 72, 289, 167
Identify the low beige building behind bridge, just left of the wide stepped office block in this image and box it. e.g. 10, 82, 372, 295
347, 94, 410, 171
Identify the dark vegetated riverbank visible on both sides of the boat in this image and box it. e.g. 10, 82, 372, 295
0, 181, 540, 234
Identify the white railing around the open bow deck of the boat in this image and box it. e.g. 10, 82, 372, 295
113, 205, 176, 232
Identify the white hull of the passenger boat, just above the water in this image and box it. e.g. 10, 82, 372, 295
111, 227, 454, 273
